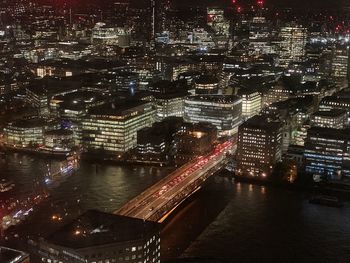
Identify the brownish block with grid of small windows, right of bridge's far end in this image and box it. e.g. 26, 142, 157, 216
237, 116, 282, 178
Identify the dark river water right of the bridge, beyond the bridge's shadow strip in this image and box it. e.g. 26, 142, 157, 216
185, 184, 350, 262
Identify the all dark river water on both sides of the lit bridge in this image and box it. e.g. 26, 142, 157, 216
0, 154, 350, 263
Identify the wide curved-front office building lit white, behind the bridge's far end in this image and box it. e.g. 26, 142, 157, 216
184, 95, 242, 136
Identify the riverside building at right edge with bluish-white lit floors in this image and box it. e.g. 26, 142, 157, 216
304, 127, 350, 180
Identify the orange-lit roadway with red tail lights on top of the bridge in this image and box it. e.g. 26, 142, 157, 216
115, 141, 232, 220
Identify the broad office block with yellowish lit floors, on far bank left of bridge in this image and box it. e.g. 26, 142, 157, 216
82, 101, 155, 154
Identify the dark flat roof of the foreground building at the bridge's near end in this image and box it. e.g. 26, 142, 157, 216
46, 210, 160, 249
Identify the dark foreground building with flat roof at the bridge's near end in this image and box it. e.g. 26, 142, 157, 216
36, 210, 160, 263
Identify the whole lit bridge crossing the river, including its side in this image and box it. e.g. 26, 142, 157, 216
115, 141, 233, 222
